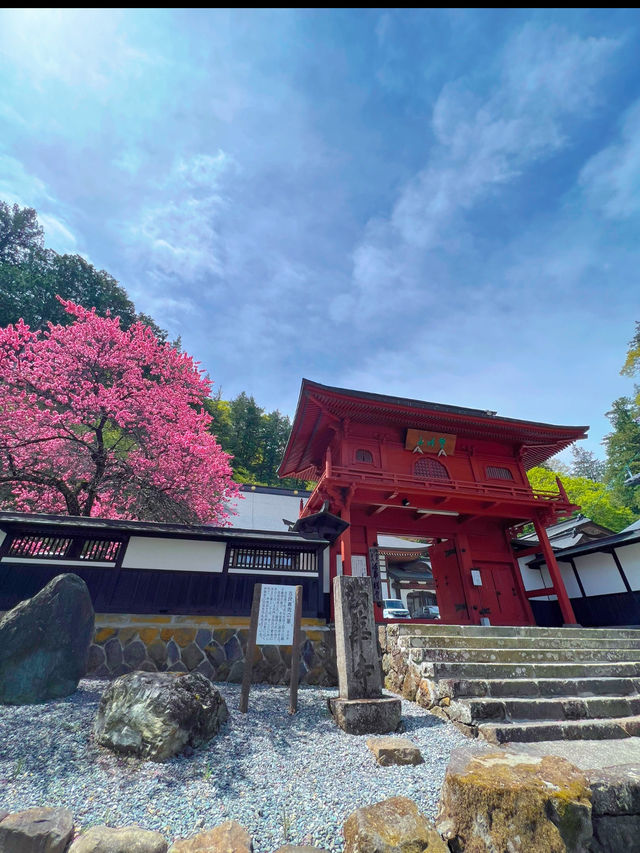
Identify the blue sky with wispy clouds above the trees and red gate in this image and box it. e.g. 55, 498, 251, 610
0, 9, 640, 455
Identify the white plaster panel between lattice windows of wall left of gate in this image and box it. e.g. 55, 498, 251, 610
122, 536, 225, 572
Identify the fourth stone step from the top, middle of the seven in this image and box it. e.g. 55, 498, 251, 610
420, 661, 640, 680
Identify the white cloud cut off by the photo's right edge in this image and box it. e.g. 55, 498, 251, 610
580, 101, 640, 219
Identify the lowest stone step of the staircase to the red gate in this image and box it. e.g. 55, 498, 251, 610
478, 716, 640, 743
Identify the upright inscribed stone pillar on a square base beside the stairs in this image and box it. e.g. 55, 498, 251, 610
329, 575, 401, 735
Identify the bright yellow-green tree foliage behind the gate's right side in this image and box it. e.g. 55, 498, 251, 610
528, 467, 635, 533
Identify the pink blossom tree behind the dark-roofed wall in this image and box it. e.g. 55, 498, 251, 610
0, 300, 237, 524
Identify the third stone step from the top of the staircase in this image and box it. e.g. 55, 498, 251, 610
407, 647, 640, 664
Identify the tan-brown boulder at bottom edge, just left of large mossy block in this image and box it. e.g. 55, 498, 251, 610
342, 797, 449, 853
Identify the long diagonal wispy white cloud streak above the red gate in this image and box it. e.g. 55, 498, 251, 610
353, 26, 618, 322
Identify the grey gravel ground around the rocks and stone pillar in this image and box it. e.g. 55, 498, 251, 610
0, 680, 476, 853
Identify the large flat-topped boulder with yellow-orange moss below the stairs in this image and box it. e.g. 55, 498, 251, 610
436, 747, 593, 853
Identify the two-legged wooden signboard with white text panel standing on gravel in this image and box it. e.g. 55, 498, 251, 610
240, 583, 302, 714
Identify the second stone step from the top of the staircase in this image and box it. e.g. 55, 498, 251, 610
399, 634, 640, 650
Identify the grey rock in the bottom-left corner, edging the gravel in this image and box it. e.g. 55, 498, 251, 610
0, 808, 73, 853
